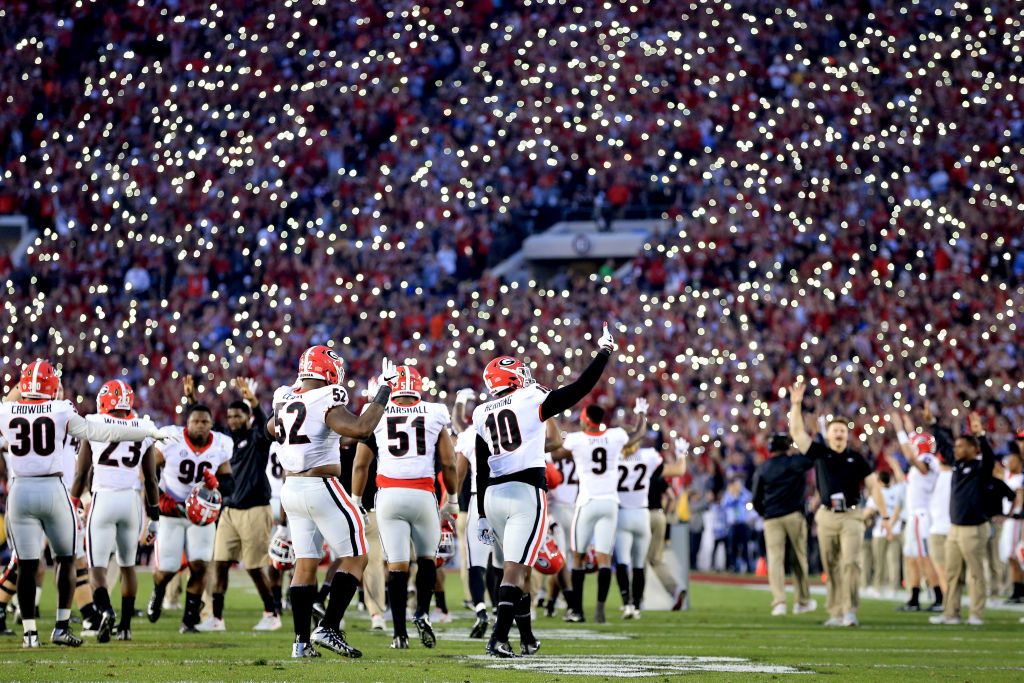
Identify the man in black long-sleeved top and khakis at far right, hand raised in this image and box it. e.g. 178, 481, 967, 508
929, 414, 995, 626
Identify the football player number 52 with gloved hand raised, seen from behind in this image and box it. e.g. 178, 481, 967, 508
267, 346, 398, 657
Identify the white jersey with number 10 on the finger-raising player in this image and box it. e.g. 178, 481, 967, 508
473, 384, 548, 477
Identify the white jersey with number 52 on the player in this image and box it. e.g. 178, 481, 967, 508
273, 384, 348, 472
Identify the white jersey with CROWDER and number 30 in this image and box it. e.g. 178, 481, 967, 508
0, 400, 78, 477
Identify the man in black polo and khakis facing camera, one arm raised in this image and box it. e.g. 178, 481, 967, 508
790, 379, 892, 627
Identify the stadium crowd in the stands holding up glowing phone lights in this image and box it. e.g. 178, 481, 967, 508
0, 0, 1024, 589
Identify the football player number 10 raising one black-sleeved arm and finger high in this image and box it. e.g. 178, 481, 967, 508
472, 325, 615, 657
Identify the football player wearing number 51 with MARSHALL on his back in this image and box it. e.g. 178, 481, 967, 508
352, 366, 459, 649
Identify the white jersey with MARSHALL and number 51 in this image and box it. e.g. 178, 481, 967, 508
374, 400, 452, 479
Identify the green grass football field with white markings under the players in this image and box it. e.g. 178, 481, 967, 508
0, 572, 1024, 683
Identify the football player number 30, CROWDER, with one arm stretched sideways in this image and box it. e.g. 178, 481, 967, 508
0, 359, 169, 647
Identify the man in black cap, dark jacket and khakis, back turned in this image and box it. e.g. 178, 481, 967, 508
754, 434, 818, 616
